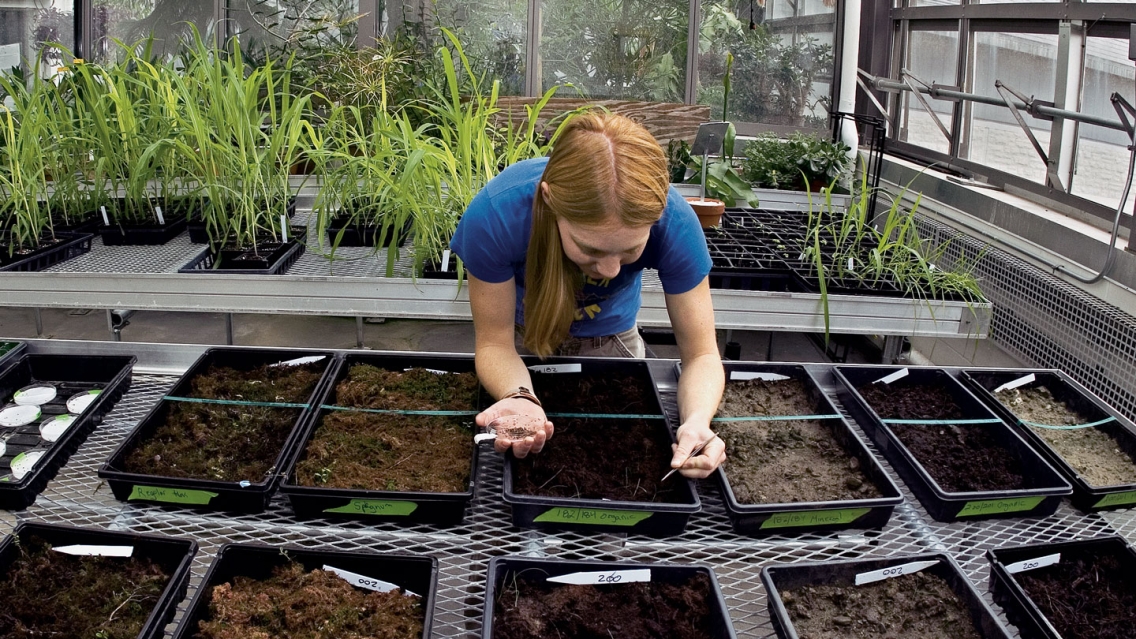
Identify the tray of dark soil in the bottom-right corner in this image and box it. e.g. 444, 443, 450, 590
986, 537, 1136, 639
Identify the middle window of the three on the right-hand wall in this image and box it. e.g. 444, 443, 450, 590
964, 33, 1058, 182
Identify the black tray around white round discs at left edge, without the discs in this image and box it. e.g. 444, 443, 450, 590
0, 347, 136, 511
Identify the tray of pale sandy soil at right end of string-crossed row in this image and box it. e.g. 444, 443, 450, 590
962, 370, 1136, 513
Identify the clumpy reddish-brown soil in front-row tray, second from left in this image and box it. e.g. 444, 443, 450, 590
195, 563, 426, 639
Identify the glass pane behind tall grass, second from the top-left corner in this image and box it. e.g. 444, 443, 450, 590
91, 0, 214, 63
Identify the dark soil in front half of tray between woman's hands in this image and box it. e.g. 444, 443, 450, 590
513, 418, 682, 503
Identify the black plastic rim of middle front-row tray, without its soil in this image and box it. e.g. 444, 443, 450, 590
482, 557, 737, 639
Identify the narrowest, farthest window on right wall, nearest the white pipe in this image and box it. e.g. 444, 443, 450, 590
897, 31, 959, 153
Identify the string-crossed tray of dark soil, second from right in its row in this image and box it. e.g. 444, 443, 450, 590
834, 366, 1072, 522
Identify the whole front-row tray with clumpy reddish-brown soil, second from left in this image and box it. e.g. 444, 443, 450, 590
174, 543, 437, 639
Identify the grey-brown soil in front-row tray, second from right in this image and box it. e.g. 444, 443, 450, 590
782, 572, 980, 639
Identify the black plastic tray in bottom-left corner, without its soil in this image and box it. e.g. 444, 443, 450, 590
0, 522, 198, 639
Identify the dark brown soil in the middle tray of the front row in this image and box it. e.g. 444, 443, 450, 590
493, 571, 711, 639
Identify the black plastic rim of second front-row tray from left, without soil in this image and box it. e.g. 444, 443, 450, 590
173, 543, 437, 639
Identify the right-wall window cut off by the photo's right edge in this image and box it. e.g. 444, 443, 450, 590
1072, 38, 1136, 210
